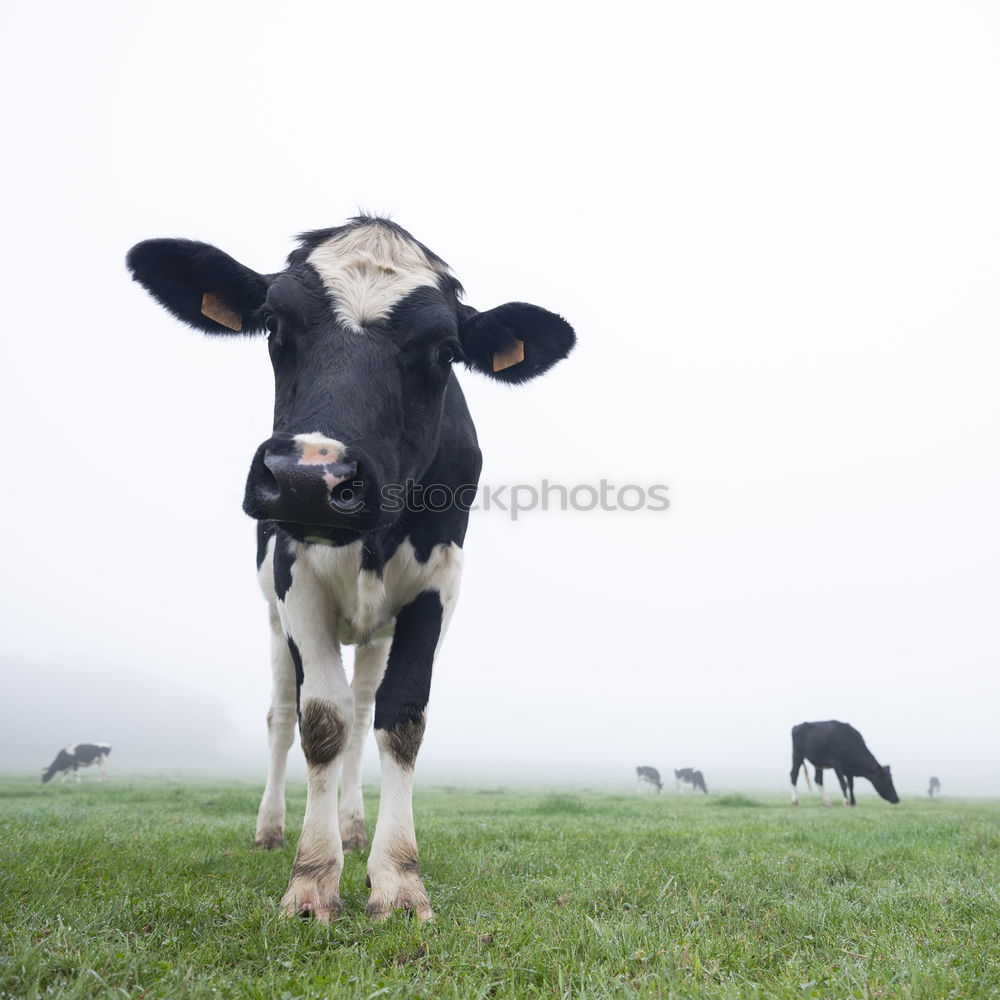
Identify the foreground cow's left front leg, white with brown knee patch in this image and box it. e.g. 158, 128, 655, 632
276, 564, 354, 921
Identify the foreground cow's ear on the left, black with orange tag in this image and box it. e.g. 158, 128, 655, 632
125, 240, 267, 334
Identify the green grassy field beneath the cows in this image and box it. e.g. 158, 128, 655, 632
0, 775, 1000, 1000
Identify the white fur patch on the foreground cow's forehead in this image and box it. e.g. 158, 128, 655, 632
308, 223, 444, 332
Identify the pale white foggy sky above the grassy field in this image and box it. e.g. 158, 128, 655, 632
0, 0, 1000, 795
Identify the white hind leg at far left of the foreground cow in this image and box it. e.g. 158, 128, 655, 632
254, 606, 295, 848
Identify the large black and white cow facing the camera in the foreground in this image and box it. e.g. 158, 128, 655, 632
128, 216, 576, 920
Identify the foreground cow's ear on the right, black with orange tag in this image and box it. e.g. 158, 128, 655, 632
459, 302, 576, 383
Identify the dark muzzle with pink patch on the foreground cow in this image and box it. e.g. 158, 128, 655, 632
243, 434, 365, 530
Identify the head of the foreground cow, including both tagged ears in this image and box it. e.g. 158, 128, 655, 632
128, 217, 575, 532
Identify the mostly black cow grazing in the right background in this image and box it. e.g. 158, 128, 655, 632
792, 719, 899, 806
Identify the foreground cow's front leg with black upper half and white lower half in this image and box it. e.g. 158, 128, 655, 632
367, 590, 451, 920
